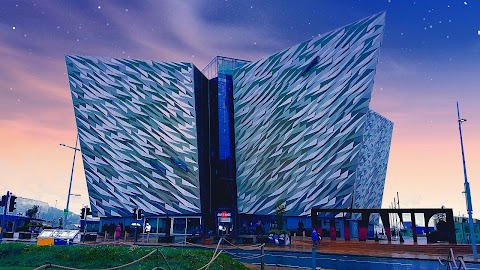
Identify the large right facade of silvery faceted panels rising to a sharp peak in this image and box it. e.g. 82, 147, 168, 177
234, 13, 385, 216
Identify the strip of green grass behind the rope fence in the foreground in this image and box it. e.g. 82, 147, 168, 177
0, 243, 253, 270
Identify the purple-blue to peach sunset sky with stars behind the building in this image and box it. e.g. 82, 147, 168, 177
0, 0, 480, 218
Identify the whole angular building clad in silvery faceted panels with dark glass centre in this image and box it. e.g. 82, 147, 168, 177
66, 13, 393, 235
